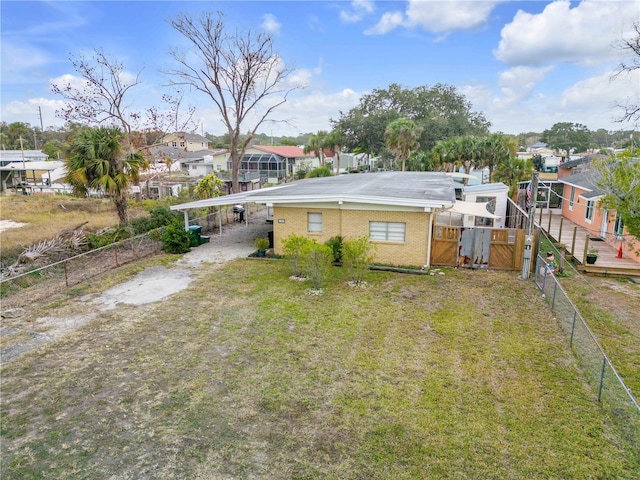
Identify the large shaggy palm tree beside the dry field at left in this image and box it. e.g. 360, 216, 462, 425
65, 127, 146, 226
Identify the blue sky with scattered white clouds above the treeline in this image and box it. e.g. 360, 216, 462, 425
0, 0, 640, 135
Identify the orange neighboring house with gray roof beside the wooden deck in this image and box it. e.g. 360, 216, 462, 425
560, 170, 640, 263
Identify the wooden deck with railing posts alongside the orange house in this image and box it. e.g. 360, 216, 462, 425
536, 210, 640, 277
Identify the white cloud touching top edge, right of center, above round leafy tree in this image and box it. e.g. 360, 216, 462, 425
365, 0, 501, 34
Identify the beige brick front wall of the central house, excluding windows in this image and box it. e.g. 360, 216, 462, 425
273, 207, 430, 266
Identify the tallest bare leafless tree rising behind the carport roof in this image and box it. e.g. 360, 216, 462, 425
165, 12, 299, 192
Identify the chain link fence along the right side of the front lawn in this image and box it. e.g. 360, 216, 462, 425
534, 251, 640, 461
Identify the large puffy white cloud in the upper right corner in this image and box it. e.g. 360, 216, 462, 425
494, 0, 640, 65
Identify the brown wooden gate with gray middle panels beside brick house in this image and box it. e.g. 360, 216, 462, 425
431, 225, 525, 270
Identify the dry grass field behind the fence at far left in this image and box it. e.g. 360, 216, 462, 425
0, 195, 146, 260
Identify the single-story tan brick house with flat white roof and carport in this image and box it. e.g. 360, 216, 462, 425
171, 172, 456, 266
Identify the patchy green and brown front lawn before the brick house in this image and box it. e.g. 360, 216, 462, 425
1, 260, 640, 479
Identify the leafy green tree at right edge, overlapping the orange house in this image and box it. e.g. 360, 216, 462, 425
594, 148, 640, 239
